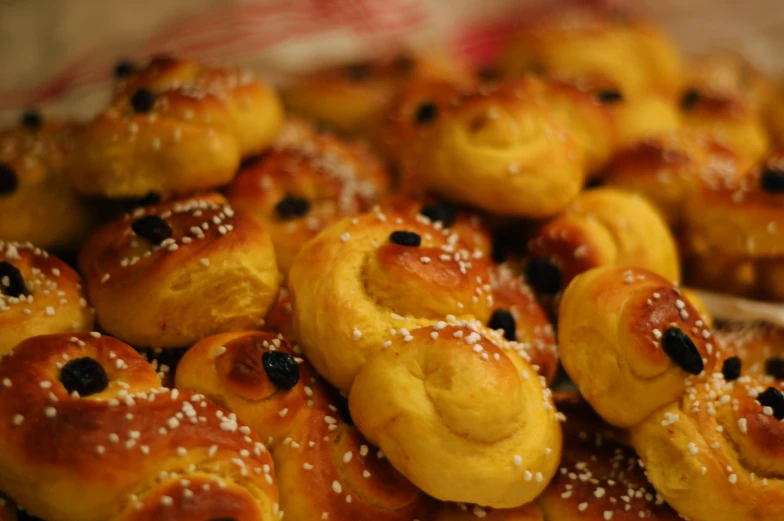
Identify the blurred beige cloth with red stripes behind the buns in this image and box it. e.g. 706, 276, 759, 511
0, 0, 784, 121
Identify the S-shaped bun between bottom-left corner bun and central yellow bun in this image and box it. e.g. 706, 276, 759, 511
177, 331, 426, 521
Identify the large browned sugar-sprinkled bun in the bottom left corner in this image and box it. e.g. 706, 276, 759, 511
0, 333, 279, 521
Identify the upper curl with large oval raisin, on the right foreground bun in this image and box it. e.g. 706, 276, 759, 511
558, 266, 718, 427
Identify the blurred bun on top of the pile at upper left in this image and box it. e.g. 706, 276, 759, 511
69, 58, 283, 198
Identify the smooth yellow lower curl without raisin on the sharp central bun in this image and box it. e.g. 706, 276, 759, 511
349, 324, 561, 508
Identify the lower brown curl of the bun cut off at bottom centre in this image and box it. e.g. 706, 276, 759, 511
273, 409, 427, 521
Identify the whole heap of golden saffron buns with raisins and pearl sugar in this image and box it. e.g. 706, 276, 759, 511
0, 5, 784, 521
